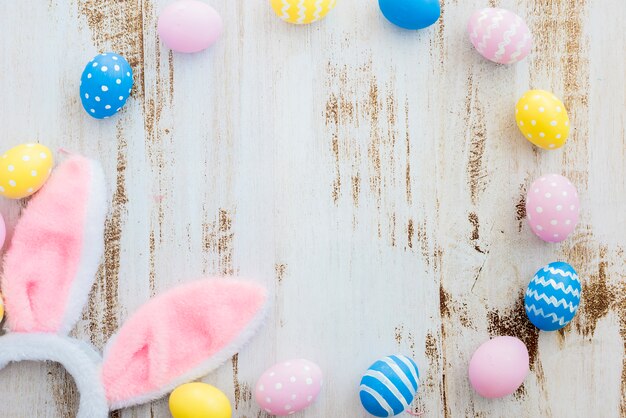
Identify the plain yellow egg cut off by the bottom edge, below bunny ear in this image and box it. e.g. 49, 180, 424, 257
170, 382, 232, 418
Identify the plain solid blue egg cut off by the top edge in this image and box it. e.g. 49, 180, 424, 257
378, 0, 441, 29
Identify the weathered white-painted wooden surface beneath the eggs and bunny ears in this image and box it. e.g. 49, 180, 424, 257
0, 0, 626, 418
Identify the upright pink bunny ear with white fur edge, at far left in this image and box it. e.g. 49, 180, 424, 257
2, 156, 107, 333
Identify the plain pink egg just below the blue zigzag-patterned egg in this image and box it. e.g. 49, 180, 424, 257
469, 337, 530, 399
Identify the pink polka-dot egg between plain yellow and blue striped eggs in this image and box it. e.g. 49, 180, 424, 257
254, 359, 322, 416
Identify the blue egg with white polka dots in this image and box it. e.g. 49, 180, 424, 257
80, 52, 133, 119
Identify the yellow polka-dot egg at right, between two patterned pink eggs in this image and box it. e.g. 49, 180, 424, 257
515, 90, 569, 149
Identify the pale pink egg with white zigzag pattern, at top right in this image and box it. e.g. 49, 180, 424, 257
467, 8, 533, 64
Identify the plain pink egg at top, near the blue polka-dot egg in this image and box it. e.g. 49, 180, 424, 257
157, 0, 224, 52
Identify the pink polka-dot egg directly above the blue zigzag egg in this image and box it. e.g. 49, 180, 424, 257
526, 174, 580, 242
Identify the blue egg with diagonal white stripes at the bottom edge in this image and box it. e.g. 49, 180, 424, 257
359, 354, 419, 417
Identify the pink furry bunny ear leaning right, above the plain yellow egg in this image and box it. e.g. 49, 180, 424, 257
102, 279, 267, 409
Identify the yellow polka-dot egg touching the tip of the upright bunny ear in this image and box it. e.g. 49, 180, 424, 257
0, 144, 54, 199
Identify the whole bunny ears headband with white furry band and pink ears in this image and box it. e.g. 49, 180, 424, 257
0, 156, 267, 418
